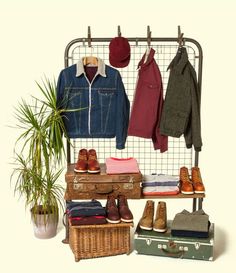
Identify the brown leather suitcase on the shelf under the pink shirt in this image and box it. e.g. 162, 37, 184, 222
65, 164, 142, 200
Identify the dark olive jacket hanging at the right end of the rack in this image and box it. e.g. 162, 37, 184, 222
160, 47, 202, 151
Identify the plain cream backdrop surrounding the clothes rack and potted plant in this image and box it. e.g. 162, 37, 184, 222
0, 0, 236, 273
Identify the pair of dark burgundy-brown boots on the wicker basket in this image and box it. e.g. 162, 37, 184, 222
106, 195, 133, 224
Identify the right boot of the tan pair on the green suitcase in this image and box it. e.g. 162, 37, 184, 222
153, 202, 167, 232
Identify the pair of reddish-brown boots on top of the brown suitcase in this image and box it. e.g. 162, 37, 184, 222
74, 149, 100, 173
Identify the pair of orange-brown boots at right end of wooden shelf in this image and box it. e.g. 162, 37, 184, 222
179, 167, 205, 194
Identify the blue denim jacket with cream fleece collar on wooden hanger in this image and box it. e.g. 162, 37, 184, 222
57, 59, 130, 149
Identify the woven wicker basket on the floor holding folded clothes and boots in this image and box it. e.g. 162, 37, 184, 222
69, 223, 133, 262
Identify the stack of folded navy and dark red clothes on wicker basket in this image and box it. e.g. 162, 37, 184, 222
66, 200, 106, 226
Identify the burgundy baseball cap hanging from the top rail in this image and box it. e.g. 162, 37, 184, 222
109, 37, 130, 68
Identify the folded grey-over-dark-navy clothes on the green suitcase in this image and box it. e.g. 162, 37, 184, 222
171, 209, 210, 238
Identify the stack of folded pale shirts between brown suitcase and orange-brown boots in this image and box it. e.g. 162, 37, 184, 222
142, 174, 179, 196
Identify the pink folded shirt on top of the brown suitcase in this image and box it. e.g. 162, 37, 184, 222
106, 157, 140, 174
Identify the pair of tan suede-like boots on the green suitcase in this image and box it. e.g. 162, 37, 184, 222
139, 200, 167, 232
